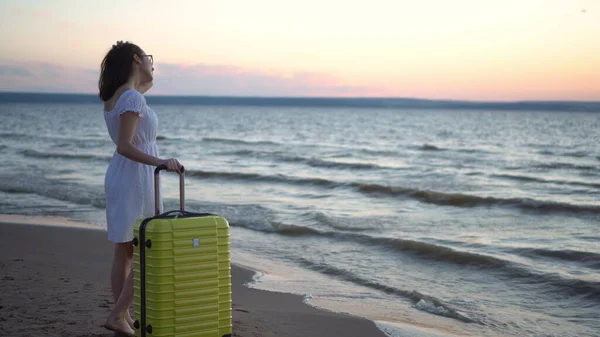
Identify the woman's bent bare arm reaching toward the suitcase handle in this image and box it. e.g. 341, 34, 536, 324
117, 111, 164, 166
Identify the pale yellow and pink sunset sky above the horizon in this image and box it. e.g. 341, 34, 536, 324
0, 0, 600, 101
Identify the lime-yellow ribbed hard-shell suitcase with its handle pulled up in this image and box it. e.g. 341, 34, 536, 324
133, 165, 232, 337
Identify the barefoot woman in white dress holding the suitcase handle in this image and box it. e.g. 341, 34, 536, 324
98, 41, 181, 336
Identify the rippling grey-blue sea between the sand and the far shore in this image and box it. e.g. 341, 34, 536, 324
0, 93, 600, 337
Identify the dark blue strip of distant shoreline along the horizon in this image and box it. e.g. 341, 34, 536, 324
0, 92, 600, 112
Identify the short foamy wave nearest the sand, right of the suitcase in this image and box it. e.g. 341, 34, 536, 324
295, 257, 481, 323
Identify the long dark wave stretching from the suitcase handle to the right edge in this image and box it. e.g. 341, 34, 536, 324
188, 171, 600, 214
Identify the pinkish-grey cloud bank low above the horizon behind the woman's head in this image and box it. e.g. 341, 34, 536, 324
0, 62, 381, 97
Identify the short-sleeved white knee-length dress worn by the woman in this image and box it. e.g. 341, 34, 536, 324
104, 89, 162, 242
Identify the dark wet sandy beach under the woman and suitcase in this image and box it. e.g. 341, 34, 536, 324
0, 215, 385, 337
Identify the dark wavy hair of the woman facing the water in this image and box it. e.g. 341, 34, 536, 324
98, 41, 142, 102
